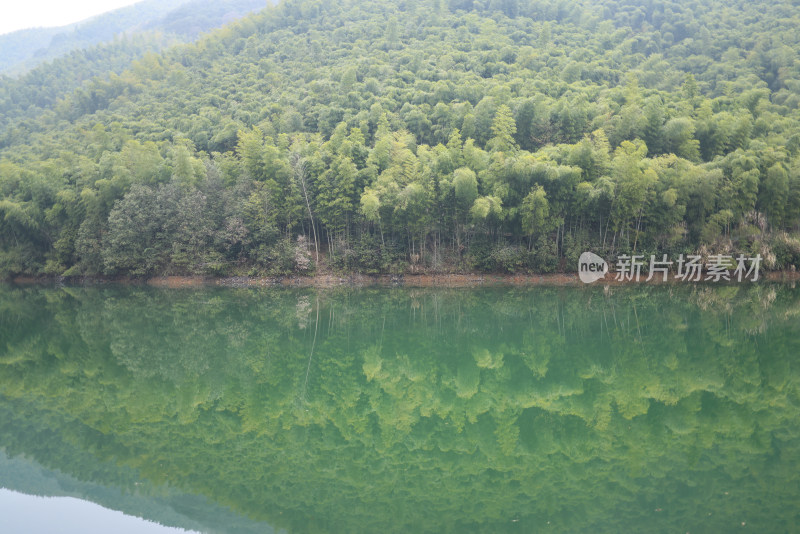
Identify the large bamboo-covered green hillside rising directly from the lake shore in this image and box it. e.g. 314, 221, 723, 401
0, 0, 800, 276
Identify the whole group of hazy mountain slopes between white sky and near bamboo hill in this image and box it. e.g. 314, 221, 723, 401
0, 0, 266, 123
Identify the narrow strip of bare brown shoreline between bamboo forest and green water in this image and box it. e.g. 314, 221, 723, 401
4, 271, 800, 288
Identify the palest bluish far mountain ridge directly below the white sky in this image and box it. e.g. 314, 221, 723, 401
0, 0, 266, 75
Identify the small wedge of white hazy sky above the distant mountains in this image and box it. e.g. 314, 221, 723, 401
0, 0, 139, 35
